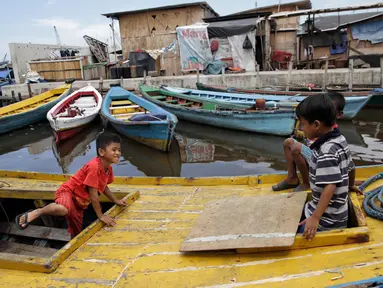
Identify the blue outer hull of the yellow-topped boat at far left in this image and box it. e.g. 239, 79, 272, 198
0, 88, 70, 134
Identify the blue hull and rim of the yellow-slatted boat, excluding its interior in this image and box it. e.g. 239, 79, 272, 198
101, 87, 178, 152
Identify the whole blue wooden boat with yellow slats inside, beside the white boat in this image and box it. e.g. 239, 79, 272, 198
101, 87, 178, 151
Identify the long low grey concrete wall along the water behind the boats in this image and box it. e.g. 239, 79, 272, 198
0, 68, 381, 100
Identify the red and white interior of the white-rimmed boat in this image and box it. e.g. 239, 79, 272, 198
52, 91, 98, 118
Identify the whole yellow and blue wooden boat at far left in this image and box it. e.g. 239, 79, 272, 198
0, 84, 71, 134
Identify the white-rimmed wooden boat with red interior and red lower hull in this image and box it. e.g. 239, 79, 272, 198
47, 85, 102, 143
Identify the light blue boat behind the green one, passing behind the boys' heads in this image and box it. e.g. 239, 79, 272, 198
183, 83, 383, 120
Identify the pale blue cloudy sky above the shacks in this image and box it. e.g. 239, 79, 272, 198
0, 0, 378, 62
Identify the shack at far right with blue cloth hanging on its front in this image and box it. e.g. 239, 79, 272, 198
298, 12, 383, 68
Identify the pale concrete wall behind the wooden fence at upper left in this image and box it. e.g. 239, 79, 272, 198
9, 43, 92, 83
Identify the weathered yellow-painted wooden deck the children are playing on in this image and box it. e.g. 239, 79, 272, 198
0, 166, 383, 288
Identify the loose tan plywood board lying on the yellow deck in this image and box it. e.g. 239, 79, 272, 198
180, 192, 307, 252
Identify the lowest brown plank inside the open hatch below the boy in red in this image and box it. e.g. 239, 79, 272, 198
0, 241, 58, 257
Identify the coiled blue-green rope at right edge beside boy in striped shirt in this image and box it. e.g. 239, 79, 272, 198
359, 172, 383, 221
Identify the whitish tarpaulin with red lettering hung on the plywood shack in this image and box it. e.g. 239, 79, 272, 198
176, 24, 213, 71
